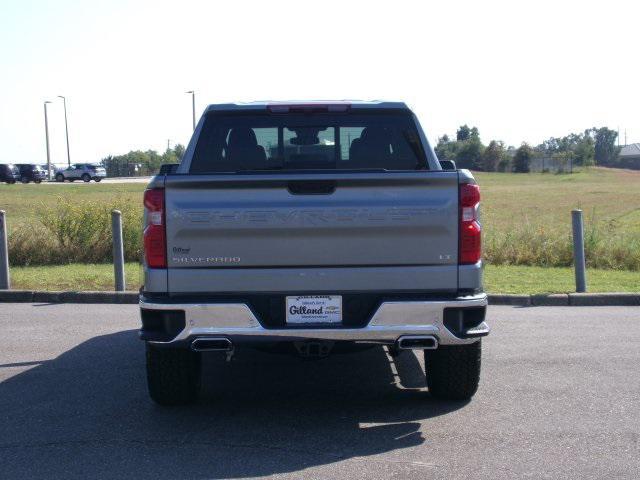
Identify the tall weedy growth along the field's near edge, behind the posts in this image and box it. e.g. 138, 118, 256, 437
9, 194, 640, 271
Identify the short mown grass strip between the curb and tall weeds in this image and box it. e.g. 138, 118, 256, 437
11, 262, 640, 294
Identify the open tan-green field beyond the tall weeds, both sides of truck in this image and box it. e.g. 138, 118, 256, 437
0, 168, 640, 233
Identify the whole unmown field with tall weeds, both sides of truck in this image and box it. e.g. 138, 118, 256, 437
0, 168, 640, 274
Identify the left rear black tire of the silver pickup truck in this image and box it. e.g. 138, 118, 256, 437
147, 343, 202, 405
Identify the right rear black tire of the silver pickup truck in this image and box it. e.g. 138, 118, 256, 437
424, 341, 482, 400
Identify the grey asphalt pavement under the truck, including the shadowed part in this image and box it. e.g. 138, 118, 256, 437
0, 304, 640, 479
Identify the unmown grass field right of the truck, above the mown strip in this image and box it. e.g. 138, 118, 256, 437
475, 168, 640, 271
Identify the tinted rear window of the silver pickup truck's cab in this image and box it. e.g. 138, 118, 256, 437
190, 111, 427, 173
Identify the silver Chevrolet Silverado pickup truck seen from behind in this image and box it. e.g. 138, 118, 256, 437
140, 102, 489, 405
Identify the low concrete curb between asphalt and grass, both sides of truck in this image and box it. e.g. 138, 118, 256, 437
0, 290, 640, 307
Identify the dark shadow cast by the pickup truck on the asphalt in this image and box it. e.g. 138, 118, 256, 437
0, 330, 465, 478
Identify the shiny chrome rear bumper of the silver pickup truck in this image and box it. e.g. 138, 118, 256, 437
140, 294, 489, 345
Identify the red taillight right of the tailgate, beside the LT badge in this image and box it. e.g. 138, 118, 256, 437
458, 183, 482, 265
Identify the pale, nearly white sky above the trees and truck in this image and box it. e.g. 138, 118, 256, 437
0, 0, 640, 164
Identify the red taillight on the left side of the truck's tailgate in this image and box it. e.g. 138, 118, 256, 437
143, 188, 167, 268
